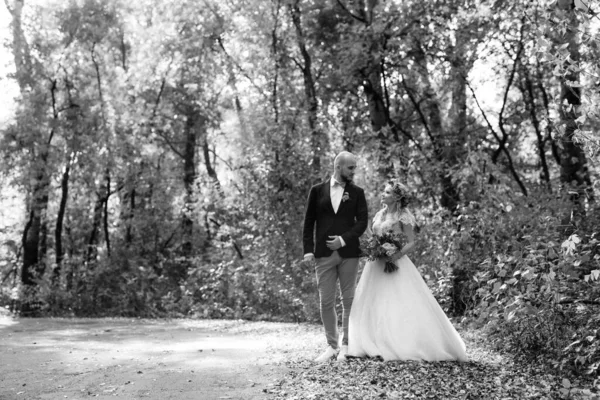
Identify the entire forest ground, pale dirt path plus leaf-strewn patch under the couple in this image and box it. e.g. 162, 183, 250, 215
0, 316, 600, 400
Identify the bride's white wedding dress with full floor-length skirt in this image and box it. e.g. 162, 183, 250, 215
348, 211, 467, 361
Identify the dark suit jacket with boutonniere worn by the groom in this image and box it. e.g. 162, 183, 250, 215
303, 179, 369, 258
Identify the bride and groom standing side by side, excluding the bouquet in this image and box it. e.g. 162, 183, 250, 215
303, 152, 467, 362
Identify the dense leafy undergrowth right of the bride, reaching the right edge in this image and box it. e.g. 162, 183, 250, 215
390, 149, 600, 376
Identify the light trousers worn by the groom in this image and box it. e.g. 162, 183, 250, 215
316, 251, 358, 349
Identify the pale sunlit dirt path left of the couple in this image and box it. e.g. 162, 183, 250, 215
0, 317, 318, 400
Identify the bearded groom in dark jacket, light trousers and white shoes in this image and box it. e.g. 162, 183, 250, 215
303, 151, 369, 362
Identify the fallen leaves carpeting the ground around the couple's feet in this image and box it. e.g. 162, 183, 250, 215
266, 328, 598, 399
